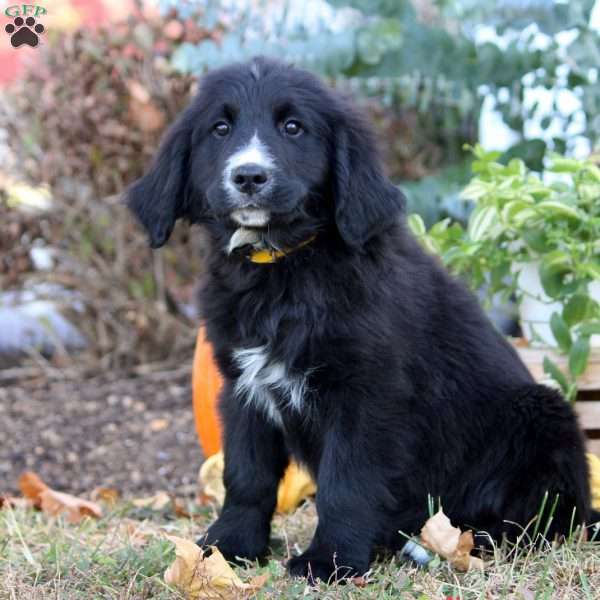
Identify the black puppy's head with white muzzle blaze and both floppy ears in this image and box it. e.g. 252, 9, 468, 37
128, 58, 403, 248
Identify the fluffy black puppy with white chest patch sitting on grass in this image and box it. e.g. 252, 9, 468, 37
128, 59, 591, 580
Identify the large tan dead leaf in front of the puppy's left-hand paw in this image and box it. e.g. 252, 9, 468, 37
164, 535, 268, 600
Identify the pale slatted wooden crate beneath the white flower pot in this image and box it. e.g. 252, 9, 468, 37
515, 344, 600, 456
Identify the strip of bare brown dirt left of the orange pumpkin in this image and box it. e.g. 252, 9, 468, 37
0, 370, 202, 496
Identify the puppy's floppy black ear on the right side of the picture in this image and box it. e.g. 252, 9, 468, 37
334, 109, 406, 247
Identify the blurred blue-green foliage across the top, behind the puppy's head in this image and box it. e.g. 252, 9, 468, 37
162, 0, 600, 220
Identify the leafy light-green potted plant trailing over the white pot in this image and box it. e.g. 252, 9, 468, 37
409, 146, 600, 400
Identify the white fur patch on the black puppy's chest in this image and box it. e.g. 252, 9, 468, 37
233, 346, 306, 427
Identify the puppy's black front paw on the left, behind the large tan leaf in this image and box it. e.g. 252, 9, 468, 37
196, 521, 268, 563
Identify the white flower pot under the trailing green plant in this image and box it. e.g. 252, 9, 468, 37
516, 262, 600, 348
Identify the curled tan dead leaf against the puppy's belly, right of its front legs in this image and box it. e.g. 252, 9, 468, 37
421, 509, 484, 571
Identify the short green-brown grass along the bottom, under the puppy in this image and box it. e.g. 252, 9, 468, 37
0, 502, 600, 600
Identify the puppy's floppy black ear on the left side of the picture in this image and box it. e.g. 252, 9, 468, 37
126, 109, 193, 248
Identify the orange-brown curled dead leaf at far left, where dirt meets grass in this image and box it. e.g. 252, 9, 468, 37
19, 471, 102, 523
